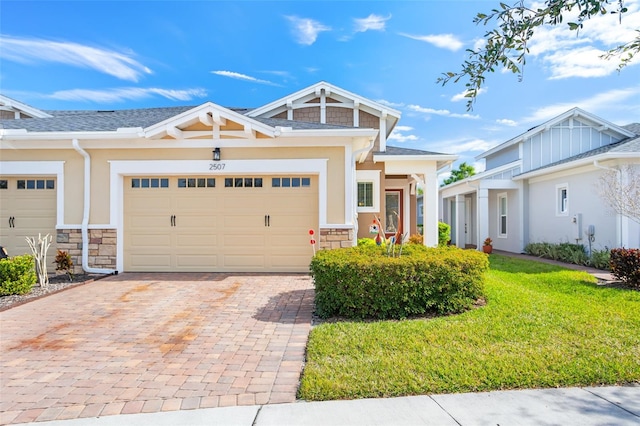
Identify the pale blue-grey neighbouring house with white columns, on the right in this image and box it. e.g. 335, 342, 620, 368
440, 108, 640, 252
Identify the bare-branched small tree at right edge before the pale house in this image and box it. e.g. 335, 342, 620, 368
597, 165, 640, 223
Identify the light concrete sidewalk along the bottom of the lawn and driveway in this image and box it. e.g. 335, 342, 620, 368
15, 385, 640, 426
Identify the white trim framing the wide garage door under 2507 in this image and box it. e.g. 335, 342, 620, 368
109, 158, 329, 271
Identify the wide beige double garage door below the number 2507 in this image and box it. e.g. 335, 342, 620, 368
124, 176, 318, 272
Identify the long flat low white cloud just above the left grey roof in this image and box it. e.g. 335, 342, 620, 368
47, 87, 207, 103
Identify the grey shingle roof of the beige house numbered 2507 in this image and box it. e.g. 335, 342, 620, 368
0, 106, 360, 132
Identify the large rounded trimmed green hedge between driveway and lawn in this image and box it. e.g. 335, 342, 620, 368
311, 244, 489, 319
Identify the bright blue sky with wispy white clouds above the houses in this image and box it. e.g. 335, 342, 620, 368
0, 0, 640, 170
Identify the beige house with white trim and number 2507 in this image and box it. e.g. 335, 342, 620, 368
0, 82, 456, 272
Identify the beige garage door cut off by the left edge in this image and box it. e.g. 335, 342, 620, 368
0, 177, 56, 258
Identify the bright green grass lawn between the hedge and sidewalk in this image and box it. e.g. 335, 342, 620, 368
299, 255, 640, 400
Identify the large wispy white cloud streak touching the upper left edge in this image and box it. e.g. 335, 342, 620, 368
0, 36, 151, 81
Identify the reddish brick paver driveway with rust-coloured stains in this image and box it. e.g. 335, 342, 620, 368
0, 273, 313, 424
